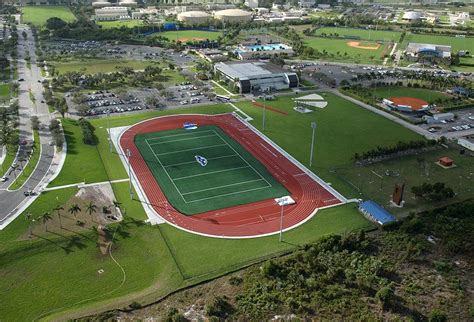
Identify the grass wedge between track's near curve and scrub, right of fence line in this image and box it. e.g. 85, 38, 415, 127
160, 204, 371, 278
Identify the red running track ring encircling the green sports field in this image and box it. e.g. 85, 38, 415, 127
120, 114, 341, 238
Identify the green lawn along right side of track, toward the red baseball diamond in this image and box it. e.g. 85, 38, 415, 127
235, 93, 422, 197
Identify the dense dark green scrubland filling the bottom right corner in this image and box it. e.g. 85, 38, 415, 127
134, 202, 474, 321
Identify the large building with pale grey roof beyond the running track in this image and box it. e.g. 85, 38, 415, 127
214, 62, 299, 94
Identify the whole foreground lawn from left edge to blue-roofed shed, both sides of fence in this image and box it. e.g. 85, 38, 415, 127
0, 177, 371, 320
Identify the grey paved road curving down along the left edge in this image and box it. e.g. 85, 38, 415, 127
0, 25, 54, 226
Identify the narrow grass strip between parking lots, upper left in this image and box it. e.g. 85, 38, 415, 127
52, 58, 158, 74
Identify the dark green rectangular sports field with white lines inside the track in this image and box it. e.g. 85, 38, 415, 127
135, 126, 289, 215
